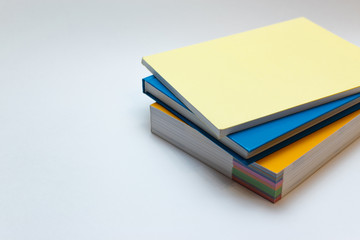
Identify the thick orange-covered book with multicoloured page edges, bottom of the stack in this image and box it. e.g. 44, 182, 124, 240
150, 103, 360, 203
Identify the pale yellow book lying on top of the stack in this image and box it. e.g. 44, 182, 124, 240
142, 18, 360, 138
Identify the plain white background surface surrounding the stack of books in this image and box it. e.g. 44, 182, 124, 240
0, 0, 360, 240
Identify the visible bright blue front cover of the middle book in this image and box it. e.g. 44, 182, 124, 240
143, 76, 360, 155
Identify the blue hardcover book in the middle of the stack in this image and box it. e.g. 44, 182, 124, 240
143, 76, 360, 159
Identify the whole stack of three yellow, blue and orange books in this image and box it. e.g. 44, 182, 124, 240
142, 18, 360, 202
